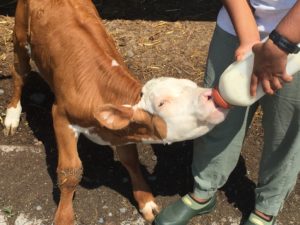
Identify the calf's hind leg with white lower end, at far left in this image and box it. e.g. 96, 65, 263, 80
3, 1, 31, 136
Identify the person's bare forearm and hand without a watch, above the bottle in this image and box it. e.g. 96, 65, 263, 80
222, 0, 260, 60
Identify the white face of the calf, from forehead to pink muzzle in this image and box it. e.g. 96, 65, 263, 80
134, 77, 227, 143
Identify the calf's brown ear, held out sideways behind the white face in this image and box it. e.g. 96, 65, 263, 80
94, 104, 133, 130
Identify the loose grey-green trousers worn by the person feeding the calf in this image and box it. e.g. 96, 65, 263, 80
192, 26, 300, 216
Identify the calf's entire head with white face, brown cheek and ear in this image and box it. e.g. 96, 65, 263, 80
94, 77, 227, 143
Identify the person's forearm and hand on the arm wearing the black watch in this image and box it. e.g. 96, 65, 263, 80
250, 0, 300, 96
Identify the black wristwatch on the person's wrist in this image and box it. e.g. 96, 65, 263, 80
269, 30, 300, 54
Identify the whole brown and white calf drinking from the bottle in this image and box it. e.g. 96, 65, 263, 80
4, 0, 226, 225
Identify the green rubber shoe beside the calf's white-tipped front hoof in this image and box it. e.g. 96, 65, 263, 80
154, 194, 216, 225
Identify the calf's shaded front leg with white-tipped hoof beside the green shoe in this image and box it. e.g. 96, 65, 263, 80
116, 145, 159, 222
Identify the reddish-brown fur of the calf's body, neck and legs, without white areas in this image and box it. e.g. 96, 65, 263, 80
8, 0, 166, 225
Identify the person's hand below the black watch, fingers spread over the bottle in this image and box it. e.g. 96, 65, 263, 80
250, 40, 293, 96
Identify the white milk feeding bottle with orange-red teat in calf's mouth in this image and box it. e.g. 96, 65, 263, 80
213, 44, 300, 108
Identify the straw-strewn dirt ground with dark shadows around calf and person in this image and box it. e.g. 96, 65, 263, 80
0, 0, 300, 225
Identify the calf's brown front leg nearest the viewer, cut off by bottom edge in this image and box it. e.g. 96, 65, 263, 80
52, 104, 82, 225
